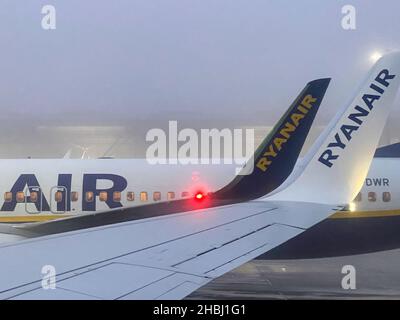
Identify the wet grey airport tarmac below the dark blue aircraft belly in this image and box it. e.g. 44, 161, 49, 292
187, 249, 400, 299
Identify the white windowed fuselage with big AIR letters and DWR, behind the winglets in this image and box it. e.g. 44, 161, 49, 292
0, 158, 400, 222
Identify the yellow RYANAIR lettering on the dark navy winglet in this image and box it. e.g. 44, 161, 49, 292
256, 94, 317, 172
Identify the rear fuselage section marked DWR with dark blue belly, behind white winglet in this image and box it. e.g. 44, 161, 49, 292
258, 143, 400, 260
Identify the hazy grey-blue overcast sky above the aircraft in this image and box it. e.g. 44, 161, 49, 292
0, 0, 400, 155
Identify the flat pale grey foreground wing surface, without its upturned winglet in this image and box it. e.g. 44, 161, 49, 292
0, 201, 337, 299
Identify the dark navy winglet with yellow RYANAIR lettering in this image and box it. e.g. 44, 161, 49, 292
212, 78, 330, 200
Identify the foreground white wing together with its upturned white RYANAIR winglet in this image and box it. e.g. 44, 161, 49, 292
0, 53, 400, 299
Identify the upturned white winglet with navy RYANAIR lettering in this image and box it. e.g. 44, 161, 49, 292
268, 52, 400, 204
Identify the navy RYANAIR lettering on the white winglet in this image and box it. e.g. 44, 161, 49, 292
318, 69, 395, 168
